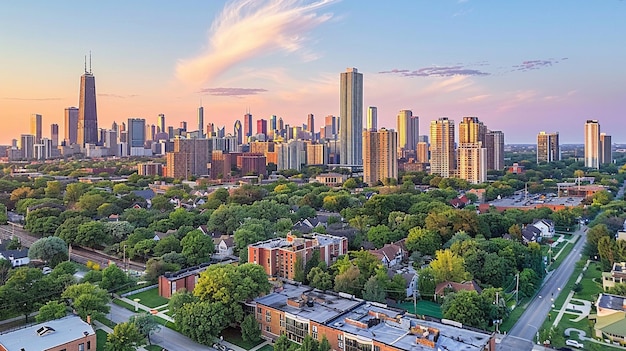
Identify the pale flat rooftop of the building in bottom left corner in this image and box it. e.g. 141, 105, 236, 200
0, 316, 96, 351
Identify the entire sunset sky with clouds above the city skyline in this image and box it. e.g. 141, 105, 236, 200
0, 0, 626, 144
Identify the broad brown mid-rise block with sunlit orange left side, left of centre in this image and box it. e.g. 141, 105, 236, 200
166, 138, 213, 179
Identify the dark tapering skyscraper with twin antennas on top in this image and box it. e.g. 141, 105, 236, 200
76, 54, 98, 147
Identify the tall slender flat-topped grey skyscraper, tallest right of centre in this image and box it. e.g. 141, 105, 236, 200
339, 68, 363, 165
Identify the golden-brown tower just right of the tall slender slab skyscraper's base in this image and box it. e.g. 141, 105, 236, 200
363, 128, 398, 185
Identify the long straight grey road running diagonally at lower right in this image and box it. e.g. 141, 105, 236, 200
498, 226, 587, 351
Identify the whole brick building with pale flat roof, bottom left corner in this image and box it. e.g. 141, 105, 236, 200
0, 316, 96, 351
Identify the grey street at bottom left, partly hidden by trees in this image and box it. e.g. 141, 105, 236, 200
106, 303, 216, 351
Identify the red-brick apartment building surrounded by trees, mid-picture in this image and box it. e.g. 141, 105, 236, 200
248, 234, 348, 280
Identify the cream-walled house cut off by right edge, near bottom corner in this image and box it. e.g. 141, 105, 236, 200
589, 294, 626, 343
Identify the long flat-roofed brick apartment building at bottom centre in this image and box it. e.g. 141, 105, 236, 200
254, 284, 496, 351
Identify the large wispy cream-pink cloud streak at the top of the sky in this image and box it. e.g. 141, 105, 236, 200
176, 0, 335, 84
